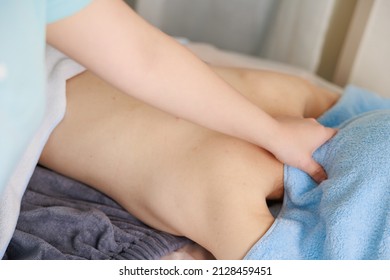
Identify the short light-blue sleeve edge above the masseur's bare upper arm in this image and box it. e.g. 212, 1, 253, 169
46, 0, 92, 23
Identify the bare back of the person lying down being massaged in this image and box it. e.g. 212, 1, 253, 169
40, 67, 338, 259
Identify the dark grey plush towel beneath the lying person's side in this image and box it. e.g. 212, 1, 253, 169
4, 166, 190, 259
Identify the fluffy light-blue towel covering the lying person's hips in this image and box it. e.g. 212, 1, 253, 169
245, 86, 390, 259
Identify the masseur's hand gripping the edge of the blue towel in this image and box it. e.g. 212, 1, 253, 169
270, 117, 337, 183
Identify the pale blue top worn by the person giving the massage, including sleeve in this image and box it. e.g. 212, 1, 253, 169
0, 0, 91, 194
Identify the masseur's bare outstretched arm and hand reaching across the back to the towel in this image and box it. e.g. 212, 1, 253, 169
47, 0, 334, 181
